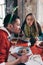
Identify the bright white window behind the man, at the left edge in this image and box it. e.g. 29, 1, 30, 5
0, 0, 5, 26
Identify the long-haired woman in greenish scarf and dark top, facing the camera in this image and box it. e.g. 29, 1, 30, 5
21, 13, 42, 44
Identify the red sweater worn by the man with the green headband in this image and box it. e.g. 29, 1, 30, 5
0, 29, 10, 63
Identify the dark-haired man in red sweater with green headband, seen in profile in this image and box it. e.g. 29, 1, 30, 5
0, 14, 28, 65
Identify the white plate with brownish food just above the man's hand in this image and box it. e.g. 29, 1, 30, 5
10, 46, 30, 56
